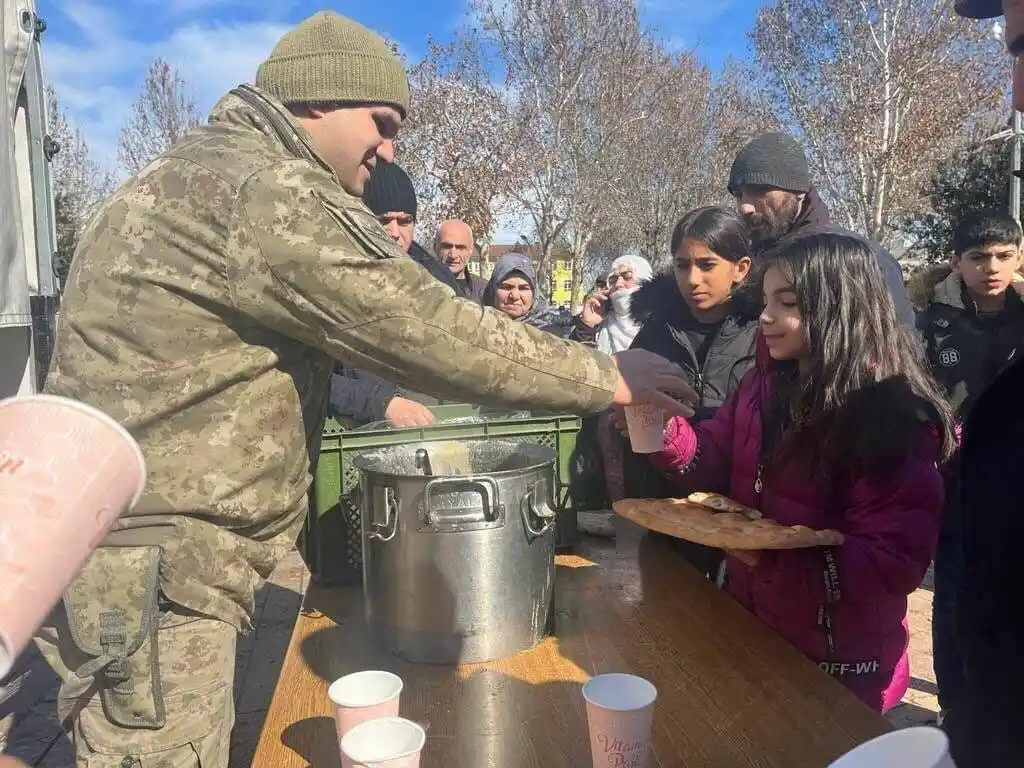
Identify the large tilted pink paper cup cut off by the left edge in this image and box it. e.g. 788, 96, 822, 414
0, 395, 145, 680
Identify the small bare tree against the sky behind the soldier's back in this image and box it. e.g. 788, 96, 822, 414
118, 58, 202, 174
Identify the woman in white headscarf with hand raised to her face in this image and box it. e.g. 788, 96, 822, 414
569, 255, 653, 354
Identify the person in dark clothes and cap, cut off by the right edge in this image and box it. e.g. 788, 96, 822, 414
942, 0, 1024, 768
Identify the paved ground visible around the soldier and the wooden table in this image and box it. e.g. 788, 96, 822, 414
0, 553, 938, 768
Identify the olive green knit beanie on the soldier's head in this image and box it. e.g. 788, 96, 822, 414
256, 10, 409, 116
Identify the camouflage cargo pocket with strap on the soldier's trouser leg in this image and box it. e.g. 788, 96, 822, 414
63, 547, 166, 728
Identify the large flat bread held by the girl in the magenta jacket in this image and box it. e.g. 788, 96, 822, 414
612, 499, 843, 549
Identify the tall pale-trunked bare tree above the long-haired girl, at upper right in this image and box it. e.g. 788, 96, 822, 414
752, 0, 1005, 240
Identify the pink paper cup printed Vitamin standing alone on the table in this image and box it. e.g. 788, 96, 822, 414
583, 673, 657, 768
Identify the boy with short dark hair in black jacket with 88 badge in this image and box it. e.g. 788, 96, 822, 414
918, 211, 1024, 723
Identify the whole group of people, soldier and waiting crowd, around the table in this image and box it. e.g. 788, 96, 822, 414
19, 0, 1024, 768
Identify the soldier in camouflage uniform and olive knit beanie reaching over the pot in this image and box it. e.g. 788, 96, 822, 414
38, 12, 686, 768
